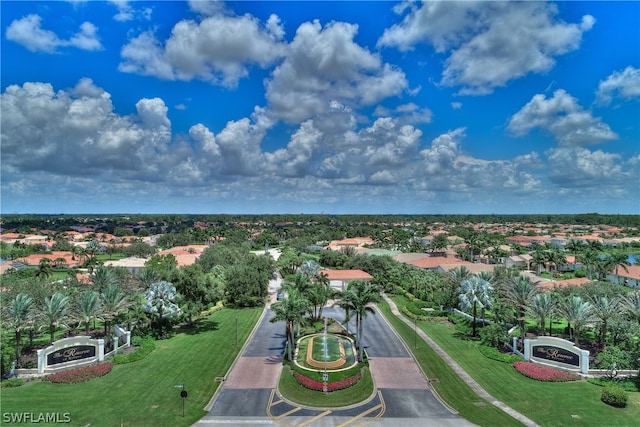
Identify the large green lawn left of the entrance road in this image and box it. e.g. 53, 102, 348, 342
2, 308, 262, 426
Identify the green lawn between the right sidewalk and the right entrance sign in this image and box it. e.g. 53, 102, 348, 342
384, 298, 640, 426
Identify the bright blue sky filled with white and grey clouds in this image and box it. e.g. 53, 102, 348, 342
0, 1, 640, 214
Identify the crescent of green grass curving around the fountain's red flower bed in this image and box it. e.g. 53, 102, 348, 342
278, 369, 373, 408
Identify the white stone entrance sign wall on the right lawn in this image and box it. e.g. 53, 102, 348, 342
524, 337, 589, 374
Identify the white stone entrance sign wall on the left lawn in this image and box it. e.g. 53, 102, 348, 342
38, 336, 104, 374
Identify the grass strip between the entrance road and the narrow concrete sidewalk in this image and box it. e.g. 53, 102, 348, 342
379, 301, 522, 426
